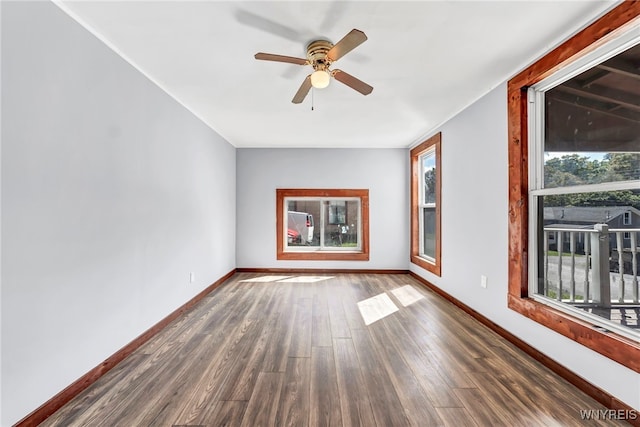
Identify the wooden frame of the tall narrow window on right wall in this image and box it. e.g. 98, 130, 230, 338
410, 132, 442, 276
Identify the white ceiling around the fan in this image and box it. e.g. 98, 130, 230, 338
56, 0, 614, 148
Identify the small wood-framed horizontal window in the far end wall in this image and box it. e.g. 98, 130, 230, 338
276, 189, 369, 260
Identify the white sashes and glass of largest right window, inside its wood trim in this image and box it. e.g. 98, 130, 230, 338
528, 36, 640, 338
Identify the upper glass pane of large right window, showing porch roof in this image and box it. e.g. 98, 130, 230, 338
544, 45, 640, 188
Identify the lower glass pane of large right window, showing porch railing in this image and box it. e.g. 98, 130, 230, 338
534, 189, 640, 304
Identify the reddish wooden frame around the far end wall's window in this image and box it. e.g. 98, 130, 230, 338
276, 188, 369, 261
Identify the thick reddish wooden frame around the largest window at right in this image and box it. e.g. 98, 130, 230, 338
507, 2, 640, 372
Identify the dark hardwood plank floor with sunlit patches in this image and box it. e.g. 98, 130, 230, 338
41, 273, 627, 427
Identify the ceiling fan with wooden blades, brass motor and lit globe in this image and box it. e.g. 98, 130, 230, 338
255, 29, 373, 104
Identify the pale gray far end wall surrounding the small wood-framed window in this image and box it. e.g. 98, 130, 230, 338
236, 148, 409, 269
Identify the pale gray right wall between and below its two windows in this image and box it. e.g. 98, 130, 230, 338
410, 84, 640, 409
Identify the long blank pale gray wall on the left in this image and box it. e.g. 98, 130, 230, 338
0, 2, 236, 426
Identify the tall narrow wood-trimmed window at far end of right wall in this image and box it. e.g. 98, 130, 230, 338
411, 133, 441, 275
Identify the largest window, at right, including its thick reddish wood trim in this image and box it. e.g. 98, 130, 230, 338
508, 2, 640, 372
